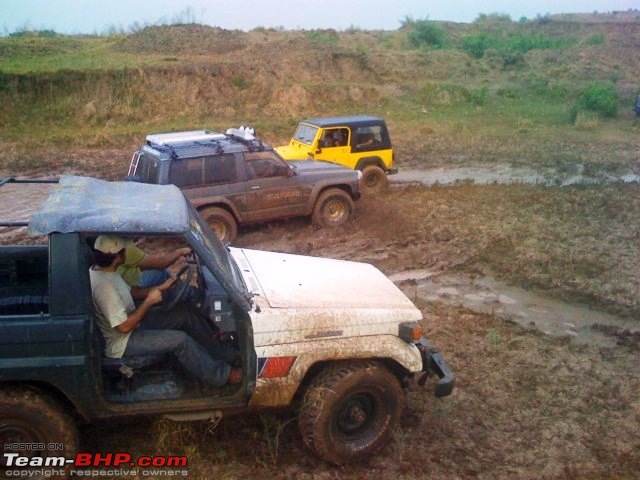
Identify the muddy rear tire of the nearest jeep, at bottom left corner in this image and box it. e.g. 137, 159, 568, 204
0, 388, 78, 479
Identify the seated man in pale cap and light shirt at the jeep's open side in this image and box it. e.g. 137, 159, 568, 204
89, 235, 242, 387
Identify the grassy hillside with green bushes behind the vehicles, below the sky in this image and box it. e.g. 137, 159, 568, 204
0, 14, 640, 175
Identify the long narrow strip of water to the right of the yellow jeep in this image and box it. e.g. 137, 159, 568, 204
389, 165, 640, 186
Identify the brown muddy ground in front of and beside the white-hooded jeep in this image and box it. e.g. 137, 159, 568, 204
2, 164, 640, 479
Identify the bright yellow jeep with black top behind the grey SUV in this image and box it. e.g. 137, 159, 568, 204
276, 115, 398, 193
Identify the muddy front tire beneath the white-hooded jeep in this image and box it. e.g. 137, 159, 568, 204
298, 361, 404, 465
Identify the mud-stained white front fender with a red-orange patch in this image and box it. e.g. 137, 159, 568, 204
249, 335, 423, 407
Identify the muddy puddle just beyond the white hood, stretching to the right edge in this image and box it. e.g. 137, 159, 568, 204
391, 270, 640, 347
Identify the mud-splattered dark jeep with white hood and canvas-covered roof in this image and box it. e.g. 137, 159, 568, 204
0, 177, 454, 468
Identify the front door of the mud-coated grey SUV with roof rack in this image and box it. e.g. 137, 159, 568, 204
244, 151, 312, 222
